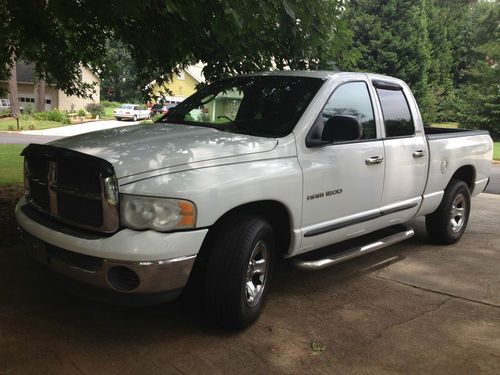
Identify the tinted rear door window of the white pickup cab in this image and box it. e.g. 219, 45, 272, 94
377, 88, 415, 138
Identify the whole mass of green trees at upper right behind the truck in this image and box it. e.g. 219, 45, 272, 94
343, 0, 500, 136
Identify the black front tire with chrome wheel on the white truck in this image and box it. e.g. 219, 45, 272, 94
204, 215, 276, 329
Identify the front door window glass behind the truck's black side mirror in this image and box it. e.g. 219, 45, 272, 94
321, 82, 377, 139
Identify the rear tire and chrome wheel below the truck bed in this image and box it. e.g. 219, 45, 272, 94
425, 179, 470, 245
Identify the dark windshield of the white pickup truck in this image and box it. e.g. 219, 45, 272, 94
160, 76, 323, 137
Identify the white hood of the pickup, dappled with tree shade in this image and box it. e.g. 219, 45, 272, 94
50, 124, 278, 178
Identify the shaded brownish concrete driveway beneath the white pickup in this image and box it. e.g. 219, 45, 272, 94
0, 194, 500, 374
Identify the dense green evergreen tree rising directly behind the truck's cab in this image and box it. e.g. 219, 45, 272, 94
344, 0, 432, 121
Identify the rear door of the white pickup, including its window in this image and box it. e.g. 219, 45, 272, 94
373, 81, 429, 219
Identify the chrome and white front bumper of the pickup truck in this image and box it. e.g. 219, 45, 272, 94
16, 199, 207, 294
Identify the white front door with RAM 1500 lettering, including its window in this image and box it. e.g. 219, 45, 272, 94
299, 80, 385, 252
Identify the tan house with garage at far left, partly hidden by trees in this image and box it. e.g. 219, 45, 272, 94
0, 62, 100, 111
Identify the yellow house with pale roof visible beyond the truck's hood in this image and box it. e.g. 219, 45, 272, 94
149, 63, 205, 103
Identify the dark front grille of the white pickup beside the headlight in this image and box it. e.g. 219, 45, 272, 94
23, 145, 119, 233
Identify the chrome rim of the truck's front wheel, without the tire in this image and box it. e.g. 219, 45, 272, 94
245, 241, 269, 307
